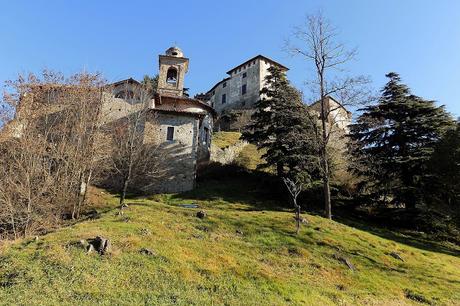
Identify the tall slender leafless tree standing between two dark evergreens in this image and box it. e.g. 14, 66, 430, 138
286, 13, 370, 219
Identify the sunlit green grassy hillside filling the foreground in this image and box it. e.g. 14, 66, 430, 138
0, 179, 460, 305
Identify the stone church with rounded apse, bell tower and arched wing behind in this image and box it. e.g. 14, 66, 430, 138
103, 47, 216, 193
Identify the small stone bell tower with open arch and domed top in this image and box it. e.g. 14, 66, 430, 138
158, 47, 189, 97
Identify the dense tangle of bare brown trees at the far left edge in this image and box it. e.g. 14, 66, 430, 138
0, 71, 107, 237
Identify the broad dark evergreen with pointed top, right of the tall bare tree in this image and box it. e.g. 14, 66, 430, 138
350, 72, 452, 208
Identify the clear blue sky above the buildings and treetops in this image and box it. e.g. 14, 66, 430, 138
0, 0, 460, 116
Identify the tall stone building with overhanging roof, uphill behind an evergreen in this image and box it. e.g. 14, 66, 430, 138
205, 55, 289, 130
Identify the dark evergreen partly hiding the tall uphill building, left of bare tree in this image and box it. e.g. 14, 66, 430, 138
242, 66, 318, 177
